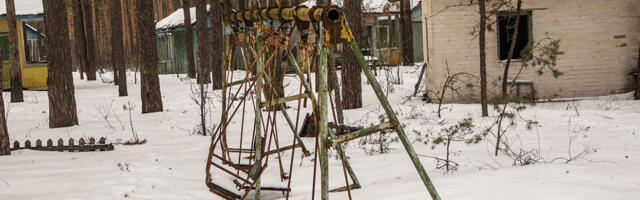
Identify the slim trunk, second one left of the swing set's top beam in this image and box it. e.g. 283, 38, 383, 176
196, 0, 211, 84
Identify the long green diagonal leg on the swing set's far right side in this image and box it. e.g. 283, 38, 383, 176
347, 30, 440, 200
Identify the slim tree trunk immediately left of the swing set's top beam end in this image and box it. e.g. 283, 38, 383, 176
211, 0, 226, 90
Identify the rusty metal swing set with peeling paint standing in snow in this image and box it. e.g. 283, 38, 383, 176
205, 2, 440, 200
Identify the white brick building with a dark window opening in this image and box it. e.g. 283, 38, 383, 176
422, 0, 640, 102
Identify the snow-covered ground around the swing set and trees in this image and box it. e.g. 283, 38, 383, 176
0, 67, 640, 200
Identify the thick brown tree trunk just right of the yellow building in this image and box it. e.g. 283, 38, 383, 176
43, 0, 78, 128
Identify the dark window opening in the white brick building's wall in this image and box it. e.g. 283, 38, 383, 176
497, 12, 531, 60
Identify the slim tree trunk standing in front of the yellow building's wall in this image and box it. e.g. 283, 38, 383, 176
5, 0, 23, 103
